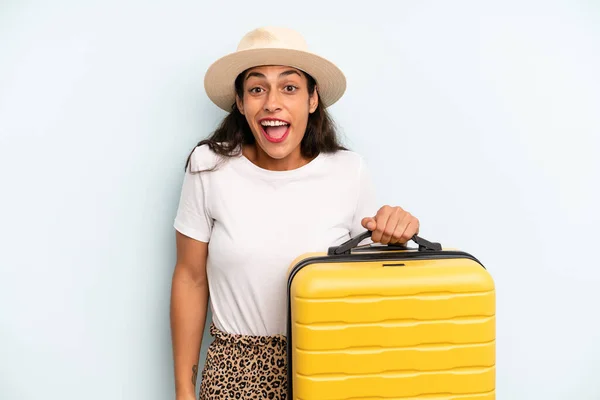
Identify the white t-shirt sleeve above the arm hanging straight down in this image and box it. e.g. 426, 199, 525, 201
174, 159, 213, 243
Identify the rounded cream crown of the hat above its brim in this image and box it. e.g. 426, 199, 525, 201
237, 26, 308, 51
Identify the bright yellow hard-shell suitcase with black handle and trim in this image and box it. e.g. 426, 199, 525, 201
287, 232, 496, 400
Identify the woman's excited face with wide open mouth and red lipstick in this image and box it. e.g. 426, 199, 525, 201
237, 66, 318, 168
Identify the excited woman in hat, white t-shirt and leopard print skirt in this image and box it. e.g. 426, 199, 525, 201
171, 28, 419, 400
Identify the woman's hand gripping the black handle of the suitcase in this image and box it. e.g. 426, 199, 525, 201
362, 205, 419, 244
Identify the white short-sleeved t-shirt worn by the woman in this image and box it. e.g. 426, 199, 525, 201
174, 145, 377, 335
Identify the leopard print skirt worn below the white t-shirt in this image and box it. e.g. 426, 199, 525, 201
200, 324, 287, 400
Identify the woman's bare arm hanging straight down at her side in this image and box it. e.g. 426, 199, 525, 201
171, 232, 208, 400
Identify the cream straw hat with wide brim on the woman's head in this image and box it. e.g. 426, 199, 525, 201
204, 27, 346, 111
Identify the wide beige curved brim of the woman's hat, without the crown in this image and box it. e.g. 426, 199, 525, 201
204, 48, 346, 112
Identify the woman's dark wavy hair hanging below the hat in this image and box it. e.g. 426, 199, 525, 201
185, 70, 347, 169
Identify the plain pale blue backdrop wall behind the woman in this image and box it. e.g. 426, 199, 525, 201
0, 0, 600, 400
